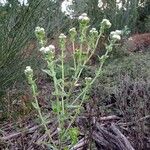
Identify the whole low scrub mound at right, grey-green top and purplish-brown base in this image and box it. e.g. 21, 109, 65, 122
88, 52, 150, 150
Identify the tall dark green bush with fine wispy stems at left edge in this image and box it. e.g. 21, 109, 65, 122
0, 1, 42, 91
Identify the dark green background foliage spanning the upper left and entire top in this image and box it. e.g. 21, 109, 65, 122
0, 0, 150, 93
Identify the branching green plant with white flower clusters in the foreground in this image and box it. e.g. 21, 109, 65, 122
25, 13, 121, 150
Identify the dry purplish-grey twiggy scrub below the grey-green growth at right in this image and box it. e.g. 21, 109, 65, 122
90, 75, 150, 150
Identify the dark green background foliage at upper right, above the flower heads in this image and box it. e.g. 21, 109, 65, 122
74, 0, 150, 33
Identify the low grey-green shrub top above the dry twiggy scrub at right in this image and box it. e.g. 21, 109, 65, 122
104, 52, 150, 79
